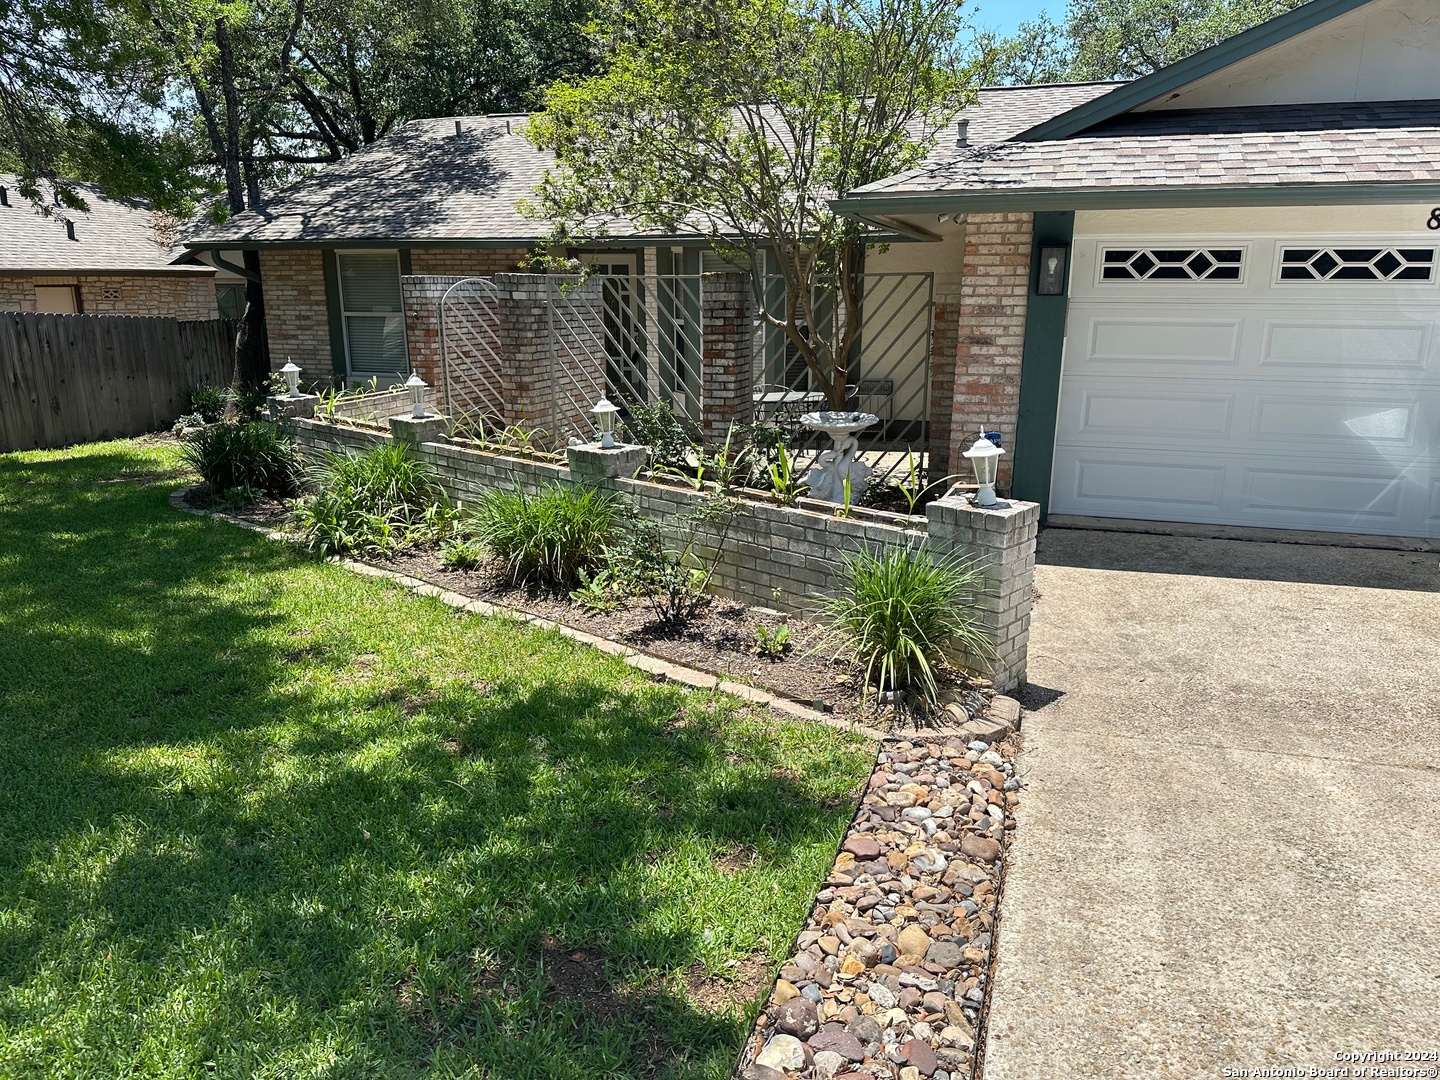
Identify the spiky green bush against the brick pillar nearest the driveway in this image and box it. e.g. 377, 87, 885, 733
822, 547, 989, 701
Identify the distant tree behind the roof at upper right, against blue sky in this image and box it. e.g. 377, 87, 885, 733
976, 0, 1305, 84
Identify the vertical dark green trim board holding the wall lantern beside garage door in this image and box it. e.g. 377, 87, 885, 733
1011, 210, 1076, 521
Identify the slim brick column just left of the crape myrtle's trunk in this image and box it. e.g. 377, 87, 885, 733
700, 279, 755, 446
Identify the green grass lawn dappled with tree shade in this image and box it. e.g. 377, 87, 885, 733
0, 442, 868, 1080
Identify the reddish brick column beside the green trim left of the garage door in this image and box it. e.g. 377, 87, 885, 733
949, 213, 1034, 488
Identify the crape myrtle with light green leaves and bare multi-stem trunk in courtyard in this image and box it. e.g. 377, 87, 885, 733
528, 0, 966, 408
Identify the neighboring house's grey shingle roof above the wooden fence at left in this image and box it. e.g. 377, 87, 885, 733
0, 174, 215, 274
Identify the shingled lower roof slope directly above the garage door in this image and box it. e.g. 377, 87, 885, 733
851, 101, 1440, 197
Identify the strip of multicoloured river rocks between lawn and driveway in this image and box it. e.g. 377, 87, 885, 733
736, 737, 1020, 1080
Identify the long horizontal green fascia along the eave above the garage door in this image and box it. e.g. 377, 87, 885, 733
832, 180, 1440, 217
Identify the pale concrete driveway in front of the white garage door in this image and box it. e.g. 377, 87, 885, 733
985, 530, 1440, 1080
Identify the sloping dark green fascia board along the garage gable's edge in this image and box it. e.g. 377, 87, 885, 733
1015, 0, 1372, 143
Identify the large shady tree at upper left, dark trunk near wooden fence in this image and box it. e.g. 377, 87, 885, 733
0, 0, 592, 382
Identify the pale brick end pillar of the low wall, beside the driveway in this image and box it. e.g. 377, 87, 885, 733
926, 498, 1040, 691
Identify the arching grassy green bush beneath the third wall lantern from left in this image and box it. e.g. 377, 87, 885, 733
469, 484, 622, 589
